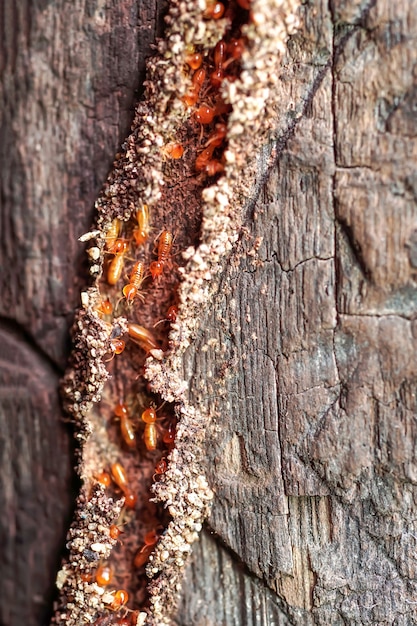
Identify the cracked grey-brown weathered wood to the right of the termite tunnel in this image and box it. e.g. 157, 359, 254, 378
178, 0, 417, 625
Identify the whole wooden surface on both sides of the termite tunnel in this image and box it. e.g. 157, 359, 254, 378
0, 0, 417, 626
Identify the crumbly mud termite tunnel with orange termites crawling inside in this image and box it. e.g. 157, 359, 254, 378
53, 0, 297, 626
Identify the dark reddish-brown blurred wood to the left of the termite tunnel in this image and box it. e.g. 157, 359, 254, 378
0, 0, 159, 626
